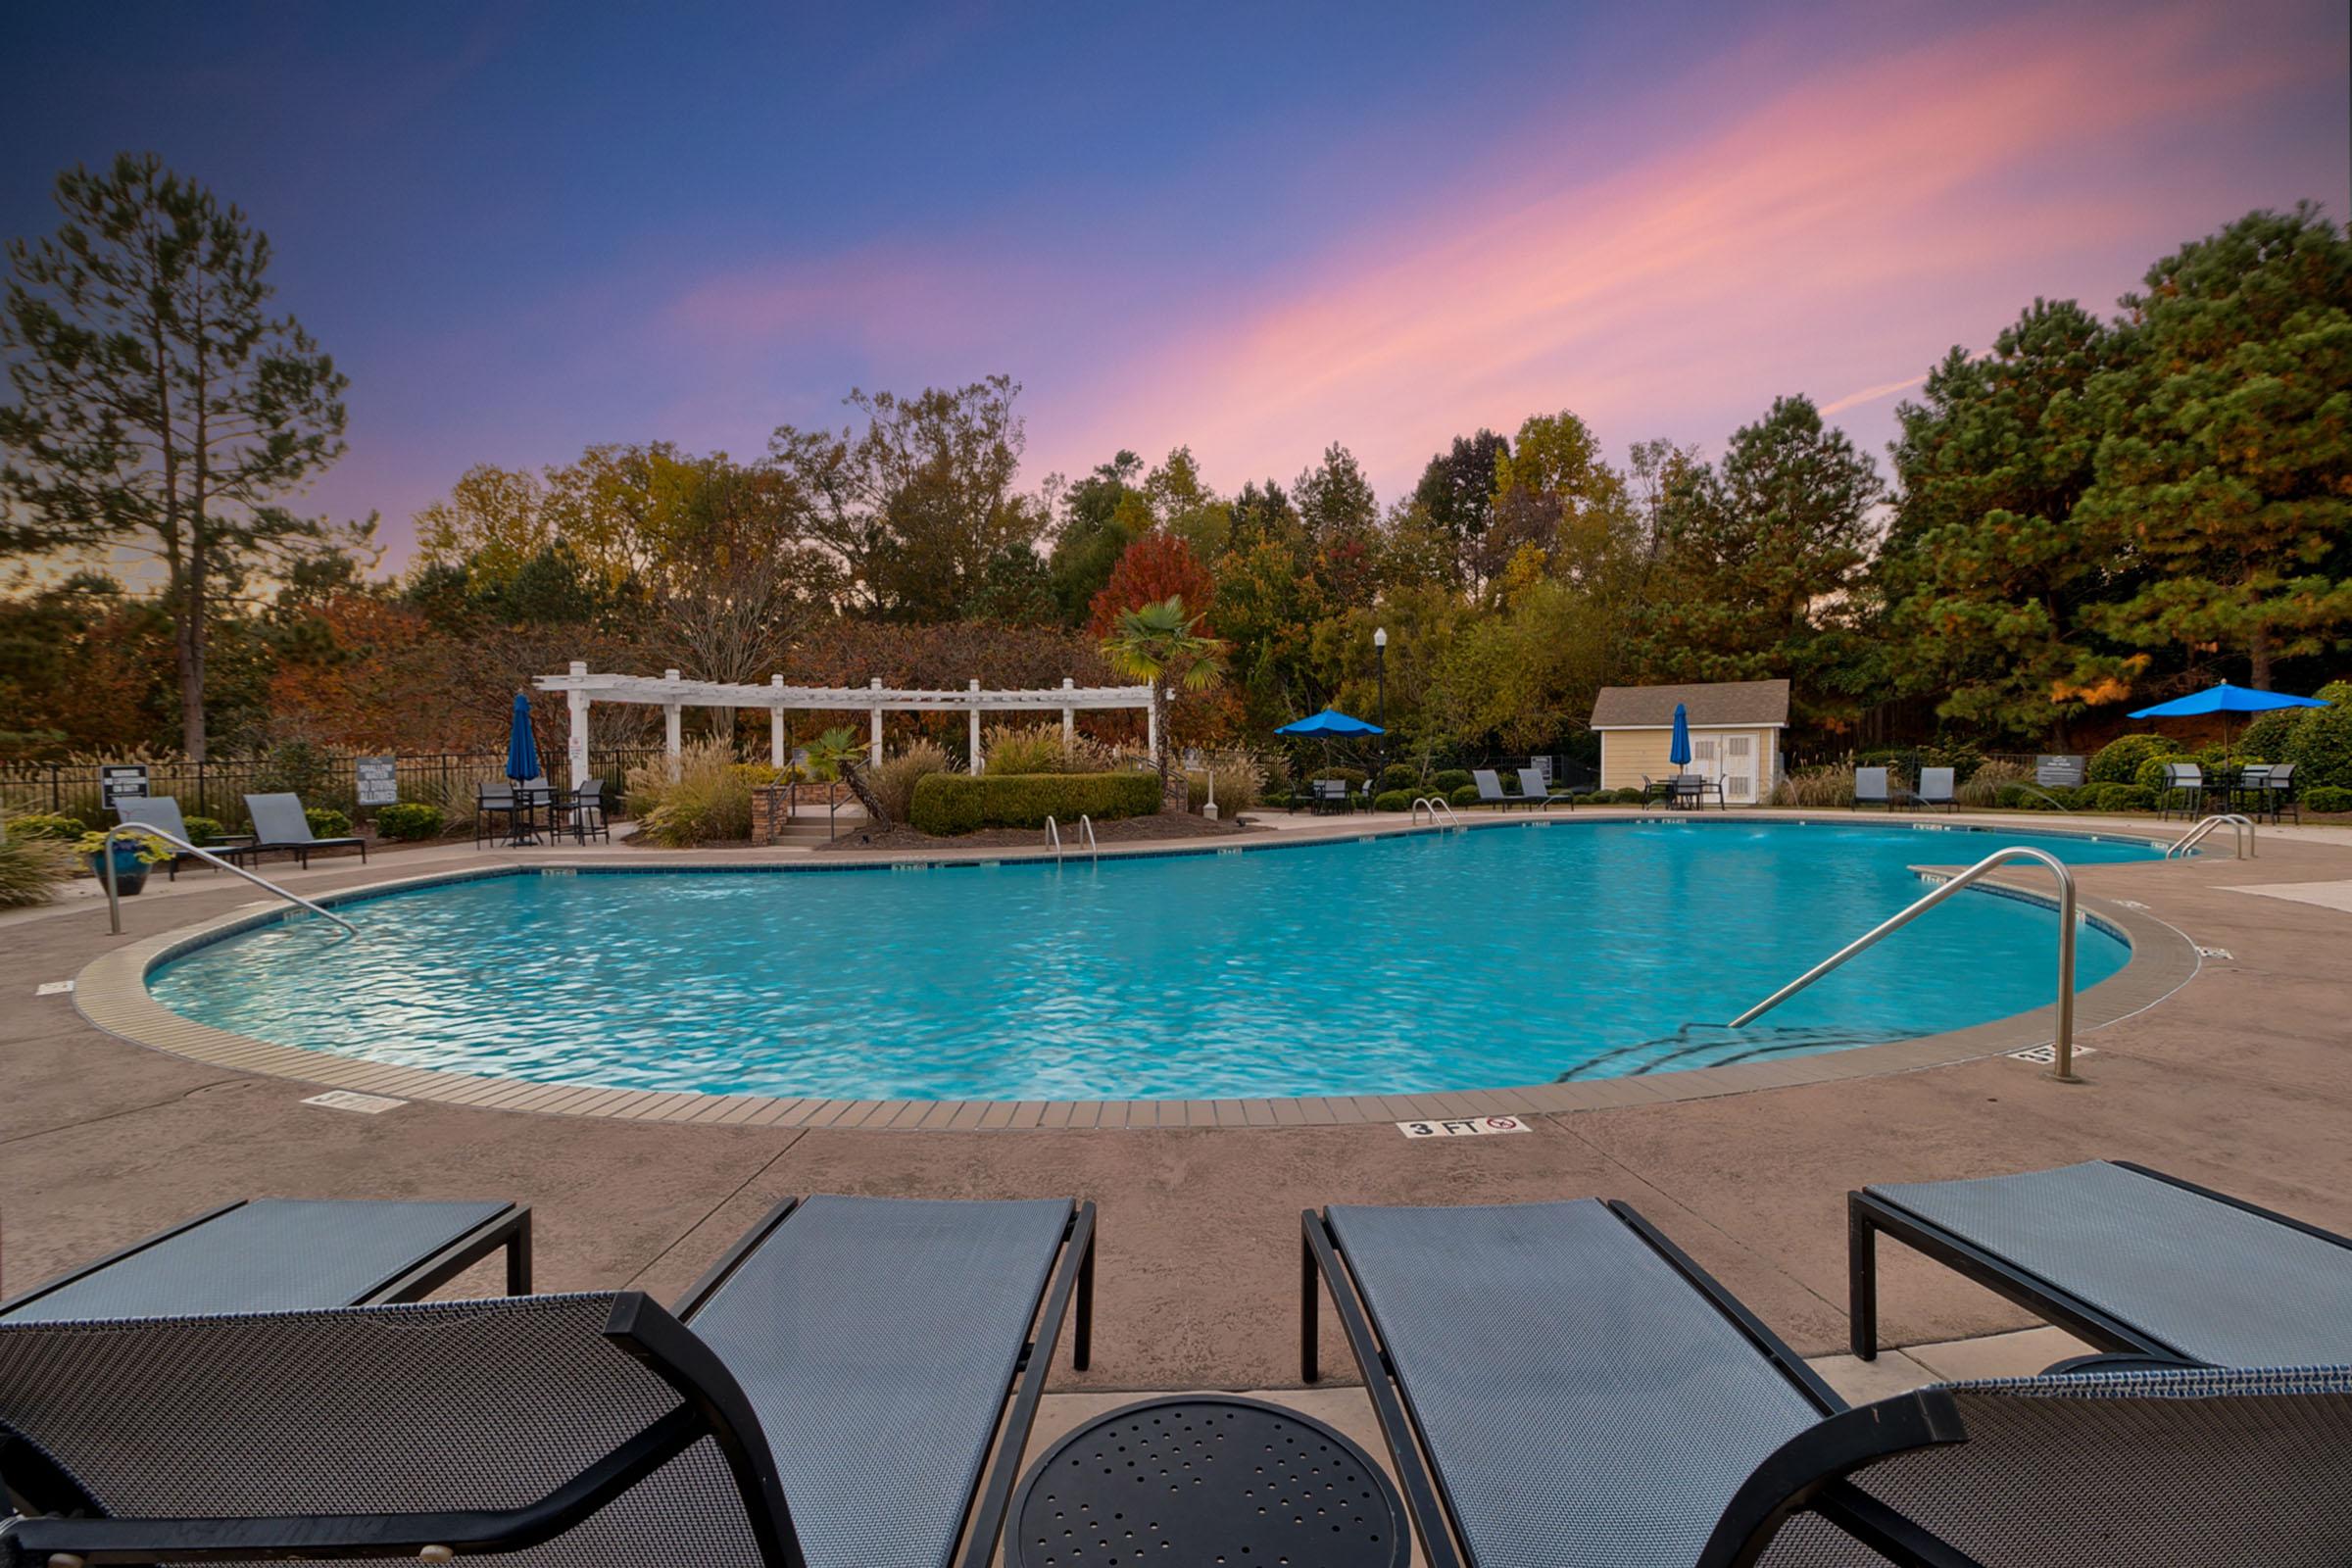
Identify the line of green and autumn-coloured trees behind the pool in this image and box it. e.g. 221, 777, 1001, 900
0, 160, 2352, 760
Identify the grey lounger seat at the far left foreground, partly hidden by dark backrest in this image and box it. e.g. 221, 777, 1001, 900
0, 1199, 531, 1324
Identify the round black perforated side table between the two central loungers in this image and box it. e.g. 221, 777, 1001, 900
1004, 1394, 1413, 1568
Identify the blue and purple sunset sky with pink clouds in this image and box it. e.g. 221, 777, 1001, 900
0, 0, 2352, 566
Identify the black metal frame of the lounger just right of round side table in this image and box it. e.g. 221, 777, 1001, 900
1298, 1199, 1976, 1568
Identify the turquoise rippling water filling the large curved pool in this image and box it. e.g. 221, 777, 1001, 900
148, 823, 2154, 1101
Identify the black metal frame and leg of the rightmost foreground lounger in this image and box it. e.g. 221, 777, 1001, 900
1846, 1159, 2352, 1366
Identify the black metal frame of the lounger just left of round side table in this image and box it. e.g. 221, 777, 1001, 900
0, 1197, 1094, 1568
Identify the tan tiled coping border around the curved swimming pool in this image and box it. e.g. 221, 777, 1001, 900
75, 813, 2199, 1131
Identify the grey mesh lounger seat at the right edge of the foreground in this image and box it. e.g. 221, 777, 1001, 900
1846, 1159, 2352, 1366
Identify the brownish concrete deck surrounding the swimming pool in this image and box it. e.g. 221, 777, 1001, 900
0, 811, 2352, 1408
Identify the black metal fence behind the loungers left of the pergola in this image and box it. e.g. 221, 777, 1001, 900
0, 745, 661, 830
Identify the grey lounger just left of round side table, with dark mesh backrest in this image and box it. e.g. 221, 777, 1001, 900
0, 1197, 1094, 1568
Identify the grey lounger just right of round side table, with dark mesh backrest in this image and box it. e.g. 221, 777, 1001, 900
1300, 1199, 2352, 1568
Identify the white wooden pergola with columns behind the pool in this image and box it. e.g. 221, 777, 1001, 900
534, 659, 1159, 778
